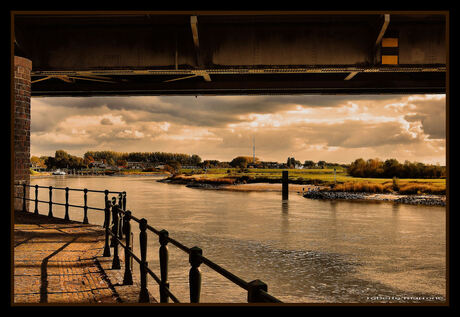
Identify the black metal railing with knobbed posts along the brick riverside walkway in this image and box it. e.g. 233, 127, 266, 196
16, 184, 281, 303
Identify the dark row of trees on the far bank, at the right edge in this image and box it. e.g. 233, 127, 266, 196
347, 158, 446, 178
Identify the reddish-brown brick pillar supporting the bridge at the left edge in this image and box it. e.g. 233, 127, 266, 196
13, 56, 32, 210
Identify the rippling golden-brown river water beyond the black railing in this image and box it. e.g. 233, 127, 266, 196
31, 176, 446, 303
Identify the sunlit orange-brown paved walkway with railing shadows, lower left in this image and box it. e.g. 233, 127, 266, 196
12, 211, 155, 304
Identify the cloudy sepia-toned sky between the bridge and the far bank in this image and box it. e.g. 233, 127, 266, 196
31, 95, 446, 165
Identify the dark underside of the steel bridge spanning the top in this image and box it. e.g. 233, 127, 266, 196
14, 12, 447, 96
